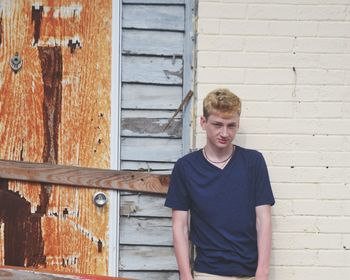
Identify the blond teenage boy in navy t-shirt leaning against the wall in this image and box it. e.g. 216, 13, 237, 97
165, 89, 275, 280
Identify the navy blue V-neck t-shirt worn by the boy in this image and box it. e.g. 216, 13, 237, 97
165, 146, 275, 277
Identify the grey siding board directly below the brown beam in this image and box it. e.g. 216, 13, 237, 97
120, 192, 172, 218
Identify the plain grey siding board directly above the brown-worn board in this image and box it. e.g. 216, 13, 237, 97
122, 83, 182, 110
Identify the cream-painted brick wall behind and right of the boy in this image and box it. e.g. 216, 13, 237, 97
194, 0, 350, 280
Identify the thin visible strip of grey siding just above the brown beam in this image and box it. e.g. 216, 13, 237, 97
120, 160, 174, 174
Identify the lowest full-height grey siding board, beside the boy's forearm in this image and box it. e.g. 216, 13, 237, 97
119, 245, 177, 270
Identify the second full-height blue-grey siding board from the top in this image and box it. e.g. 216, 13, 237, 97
122, 29, 184, 56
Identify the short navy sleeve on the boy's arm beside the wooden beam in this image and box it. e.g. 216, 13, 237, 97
164, 160, 190, 211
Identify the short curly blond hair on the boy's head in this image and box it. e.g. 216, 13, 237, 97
203, 88, 241, 119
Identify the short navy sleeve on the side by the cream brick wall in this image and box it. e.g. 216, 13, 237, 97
255, 153, 275, 206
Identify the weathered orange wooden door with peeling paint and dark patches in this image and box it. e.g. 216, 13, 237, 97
0, 0, 111, 274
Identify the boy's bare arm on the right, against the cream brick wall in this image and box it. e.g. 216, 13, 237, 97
255, 205, 272, 280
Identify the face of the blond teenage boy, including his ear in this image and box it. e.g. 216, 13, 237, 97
200, 113, 239, 149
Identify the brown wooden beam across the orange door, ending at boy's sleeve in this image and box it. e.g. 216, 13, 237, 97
0, 160, 170, 194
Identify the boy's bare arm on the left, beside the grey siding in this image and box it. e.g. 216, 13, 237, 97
173, 210, 193, 280
